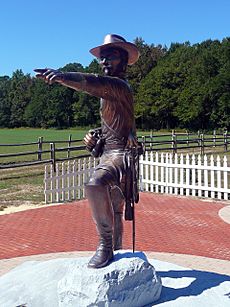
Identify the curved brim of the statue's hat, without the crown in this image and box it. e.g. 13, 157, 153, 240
89, 42, 140, 65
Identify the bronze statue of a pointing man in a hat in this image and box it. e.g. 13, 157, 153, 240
35, 34, 139, 268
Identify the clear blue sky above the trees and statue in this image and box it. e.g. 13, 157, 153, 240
0, 0, 230, 76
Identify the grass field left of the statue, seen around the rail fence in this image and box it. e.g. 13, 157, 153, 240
0, 128, 87, 210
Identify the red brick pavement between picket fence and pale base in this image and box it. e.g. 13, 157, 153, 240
0, 193, 230, 260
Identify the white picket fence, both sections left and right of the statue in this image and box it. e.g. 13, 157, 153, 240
44, 152, 230, 203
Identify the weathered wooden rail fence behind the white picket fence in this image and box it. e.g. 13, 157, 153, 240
0, 131, 230, 171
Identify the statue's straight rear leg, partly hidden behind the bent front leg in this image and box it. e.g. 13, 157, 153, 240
110, 186, 124, 250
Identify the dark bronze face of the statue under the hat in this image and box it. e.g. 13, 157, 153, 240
99, 48, 122, 76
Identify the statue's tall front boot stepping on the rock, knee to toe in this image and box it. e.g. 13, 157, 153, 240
86, 184, 114, 268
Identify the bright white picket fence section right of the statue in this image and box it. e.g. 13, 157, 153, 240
140, 152, 230, 200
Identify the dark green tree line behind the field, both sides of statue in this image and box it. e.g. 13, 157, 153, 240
0, 37, 230, 130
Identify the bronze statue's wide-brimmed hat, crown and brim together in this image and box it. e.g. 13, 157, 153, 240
89, 34, 140, 65
